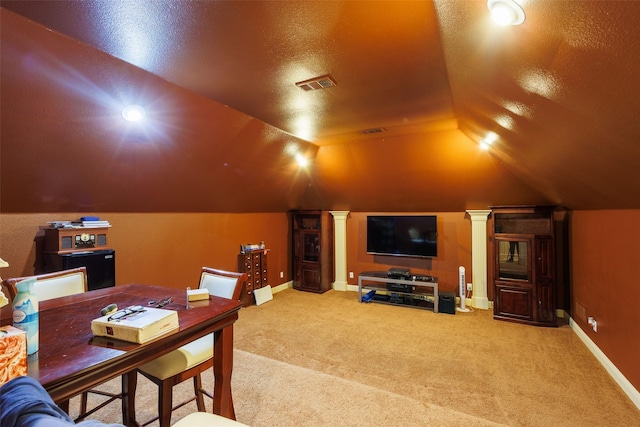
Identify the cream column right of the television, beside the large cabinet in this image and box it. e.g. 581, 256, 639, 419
467, 210, 491, 309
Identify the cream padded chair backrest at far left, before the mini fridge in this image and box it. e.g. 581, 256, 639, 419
2, 267, 87, 301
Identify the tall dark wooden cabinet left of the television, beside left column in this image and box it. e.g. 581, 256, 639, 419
291, 210, 334, 293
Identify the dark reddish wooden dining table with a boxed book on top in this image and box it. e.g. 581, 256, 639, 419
0, 284, 242, 426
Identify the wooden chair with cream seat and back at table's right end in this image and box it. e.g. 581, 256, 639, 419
127, 267, 247, 427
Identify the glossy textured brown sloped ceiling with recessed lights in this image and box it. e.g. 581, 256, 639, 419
0, 0, 640, 212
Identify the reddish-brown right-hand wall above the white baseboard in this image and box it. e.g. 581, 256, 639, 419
571, 210, 640, 389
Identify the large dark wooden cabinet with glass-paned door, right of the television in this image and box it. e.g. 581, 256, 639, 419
490, 206, 556, 326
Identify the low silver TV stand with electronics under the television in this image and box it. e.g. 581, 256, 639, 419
358, 271, 438, 313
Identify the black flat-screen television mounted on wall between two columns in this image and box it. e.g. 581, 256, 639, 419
367, 215, 438, 258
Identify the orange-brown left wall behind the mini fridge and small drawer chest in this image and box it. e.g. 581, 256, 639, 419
0, 213, 291, 288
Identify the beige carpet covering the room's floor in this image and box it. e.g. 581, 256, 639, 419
71, 290, 640, 427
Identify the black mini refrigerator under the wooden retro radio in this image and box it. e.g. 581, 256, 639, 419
44, 249, 116, 291
